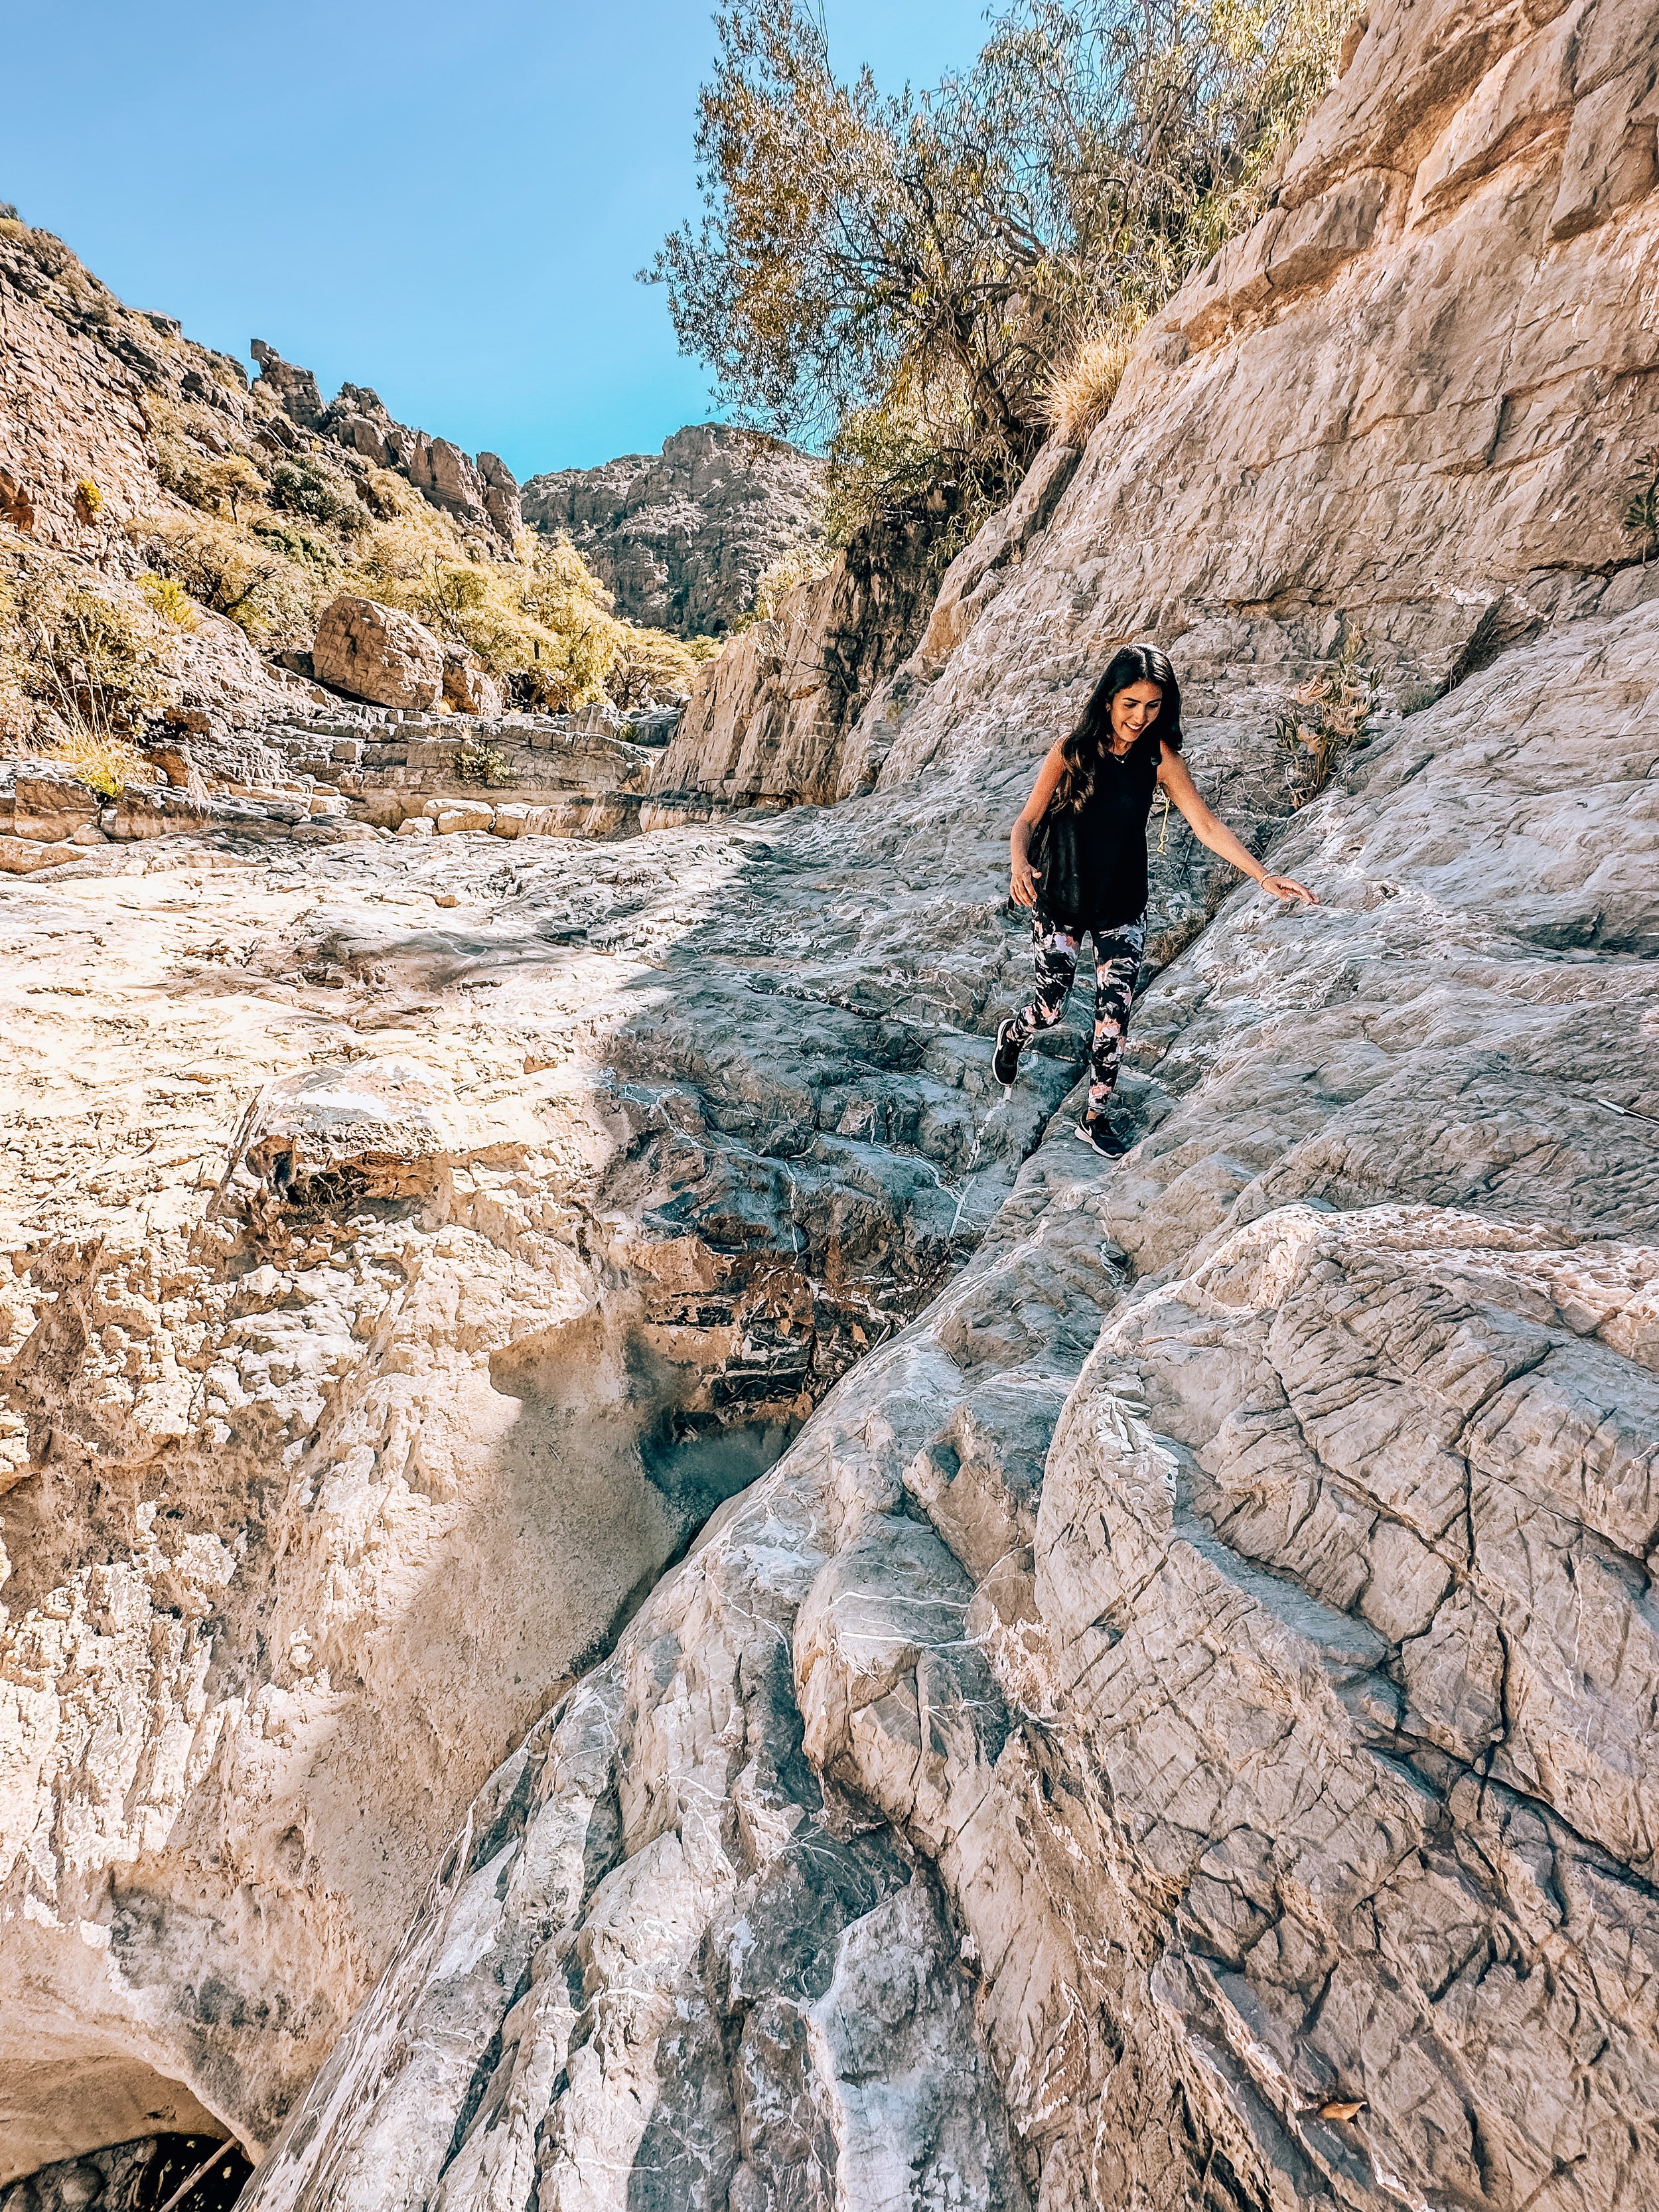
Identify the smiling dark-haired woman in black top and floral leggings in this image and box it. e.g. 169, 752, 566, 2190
991, 646, 1319, 1159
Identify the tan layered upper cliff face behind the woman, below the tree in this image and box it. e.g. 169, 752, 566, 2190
662, 0, 1659, 822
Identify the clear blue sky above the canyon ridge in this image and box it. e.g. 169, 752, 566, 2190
0, 0, 984, 476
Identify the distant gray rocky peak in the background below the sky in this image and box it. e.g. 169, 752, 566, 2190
522, 423, 823, 637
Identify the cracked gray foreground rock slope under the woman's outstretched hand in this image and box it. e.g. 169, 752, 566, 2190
248, 609, 1659, 2212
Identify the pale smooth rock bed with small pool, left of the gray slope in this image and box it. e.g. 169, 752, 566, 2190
0, 692, 1279, 2170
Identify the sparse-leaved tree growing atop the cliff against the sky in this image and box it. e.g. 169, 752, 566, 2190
642, 0, 1356, 533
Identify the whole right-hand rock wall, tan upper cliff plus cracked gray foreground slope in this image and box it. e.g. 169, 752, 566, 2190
236, 5, 1659, 2212
